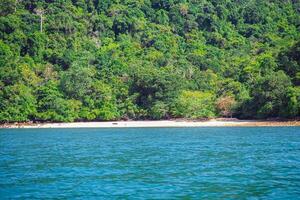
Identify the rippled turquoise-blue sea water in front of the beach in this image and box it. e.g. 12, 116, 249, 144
0, 127, 300, 199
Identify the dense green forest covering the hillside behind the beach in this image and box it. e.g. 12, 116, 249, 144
0, 0, 300, 123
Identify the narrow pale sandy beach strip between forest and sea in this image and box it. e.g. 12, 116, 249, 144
0, 119, 300, 128
